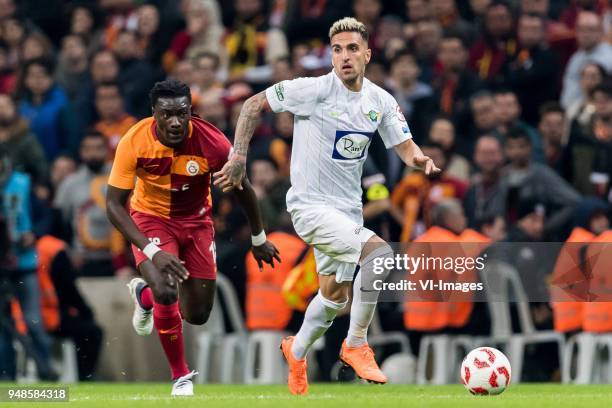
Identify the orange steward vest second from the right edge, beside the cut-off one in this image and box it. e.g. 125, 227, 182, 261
551, 227, 595, 333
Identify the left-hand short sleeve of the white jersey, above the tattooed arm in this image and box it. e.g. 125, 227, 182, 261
266, 78, 319, 116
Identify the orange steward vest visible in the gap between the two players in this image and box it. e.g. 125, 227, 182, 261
246, 232, 306, 330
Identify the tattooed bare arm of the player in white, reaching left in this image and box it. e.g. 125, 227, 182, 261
213, 91, 270, 192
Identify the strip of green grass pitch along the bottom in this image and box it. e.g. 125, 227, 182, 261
0, 383, 612, 408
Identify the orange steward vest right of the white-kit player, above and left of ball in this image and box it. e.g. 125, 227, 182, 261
404, 227, 490, 331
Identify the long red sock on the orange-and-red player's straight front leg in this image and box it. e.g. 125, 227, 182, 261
153, 301, 189, 380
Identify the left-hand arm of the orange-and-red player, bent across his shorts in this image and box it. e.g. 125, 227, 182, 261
106, 185, 189, 282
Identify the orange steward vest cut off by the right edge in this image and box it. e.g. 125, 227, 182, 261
582, 230, 612, 333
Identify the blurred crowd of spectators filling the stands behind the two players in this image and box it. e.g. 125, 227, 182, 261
0, 0, 612, 380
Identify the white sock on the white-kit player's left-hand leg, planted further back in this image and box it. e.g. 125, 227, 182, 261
291, 292, 348, 360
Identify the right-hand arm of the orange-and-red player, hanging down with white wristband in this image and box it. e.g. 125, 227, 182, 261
234, 177, 281, 269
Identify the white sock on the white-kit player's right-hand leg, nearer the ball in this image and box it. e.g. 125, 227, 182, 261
346, 245, 393, 347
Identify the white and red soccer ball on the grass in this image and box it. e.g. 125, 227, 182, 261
460, 347, 511, 395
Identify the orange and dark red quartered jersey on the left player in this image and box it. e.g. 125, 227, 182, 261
108, 117, 232, 219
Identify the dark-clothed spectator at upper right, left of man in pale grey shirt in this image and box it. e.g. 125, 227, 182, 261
503, 14, 559, 126
